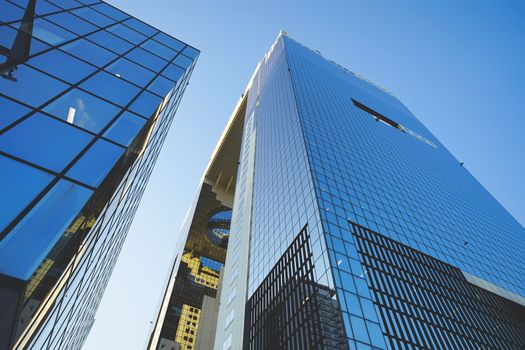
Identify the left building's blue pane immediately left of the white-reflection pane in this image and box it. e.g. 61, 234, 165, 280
0, 65, 68, 107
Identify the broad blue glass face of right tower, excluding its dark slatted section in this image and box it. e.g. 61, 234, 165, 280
276, 36, 525, 349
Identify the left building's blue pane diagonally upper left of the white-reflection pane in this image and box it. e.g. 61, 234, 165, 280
28, 50, 96, 84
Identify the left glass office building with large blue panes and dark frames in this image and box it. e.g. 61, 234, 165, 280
0, 0, 199, 349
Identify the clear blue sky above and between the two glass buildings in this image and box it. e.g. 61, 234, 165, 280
85, 0, 525, 350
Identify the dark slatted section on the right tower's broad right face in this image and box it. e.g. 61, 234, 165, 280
352, 223, 525, 349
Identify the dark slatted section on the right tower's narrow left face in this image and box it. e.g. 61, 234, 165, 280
244, 227, 346, 349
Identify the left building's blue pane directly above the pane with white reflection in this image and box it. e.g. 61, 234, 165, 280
80, 72, 140, 106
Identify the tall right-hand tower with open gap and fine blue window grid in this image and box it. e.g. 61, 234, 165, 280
150, 33, 525, 350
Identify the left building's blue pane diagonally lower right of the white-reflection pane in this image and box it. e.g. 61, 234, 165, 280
67, 139, 124, 187
